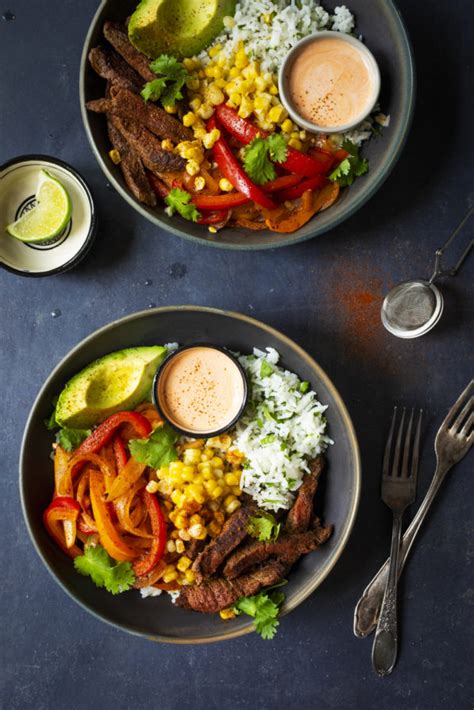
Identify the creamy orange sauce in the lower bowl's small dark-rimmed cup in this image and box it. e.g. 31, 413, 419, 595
156, 346, 245, 435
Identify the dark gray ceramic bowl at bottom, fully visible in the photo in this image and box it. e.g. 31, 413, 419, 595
20, 306, 360, 643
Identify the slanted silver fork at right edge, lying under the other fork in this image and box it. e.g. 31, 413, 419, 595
354, 380, 474, 638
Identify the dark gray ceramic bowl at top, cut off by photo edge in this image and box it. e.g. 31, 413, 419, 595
80, 0, 415, 249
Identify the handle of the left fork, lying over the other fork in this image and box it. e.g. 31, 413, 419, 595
372, 512, 402, 676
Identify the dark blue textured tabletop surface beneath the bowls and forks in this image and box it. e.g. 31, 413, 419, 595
0, 0, 474, 710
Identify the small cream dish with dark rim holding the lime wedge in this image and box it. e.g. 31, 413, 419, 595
0, 155, 97, 276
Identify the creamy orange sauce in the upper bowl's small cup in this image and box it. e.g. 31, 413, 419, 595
288, 37, 374, 128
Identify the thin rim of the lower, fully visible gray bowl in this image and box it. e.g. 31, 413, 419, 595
19, 305, 361, 645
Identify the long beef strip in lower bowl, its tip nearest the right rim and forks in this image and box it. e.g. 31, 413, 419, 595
223, 526, 332, 579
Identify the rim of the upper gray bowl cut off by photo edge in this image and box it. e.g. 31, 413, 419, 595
79, 0, 416, 251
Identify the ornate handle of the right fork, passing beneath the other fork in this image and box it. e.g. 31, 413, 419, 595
354, 461, 454, 638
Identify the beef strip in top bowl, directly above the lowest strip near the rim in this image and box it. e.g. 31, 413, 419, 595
110, 116, 186, 176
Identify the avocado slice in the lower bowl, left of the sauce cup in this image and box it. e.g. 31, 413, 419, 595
56, 345, 167, 429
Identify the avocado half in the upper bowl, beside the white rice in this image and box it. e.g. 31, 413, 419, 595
128, 0, 236, 59
